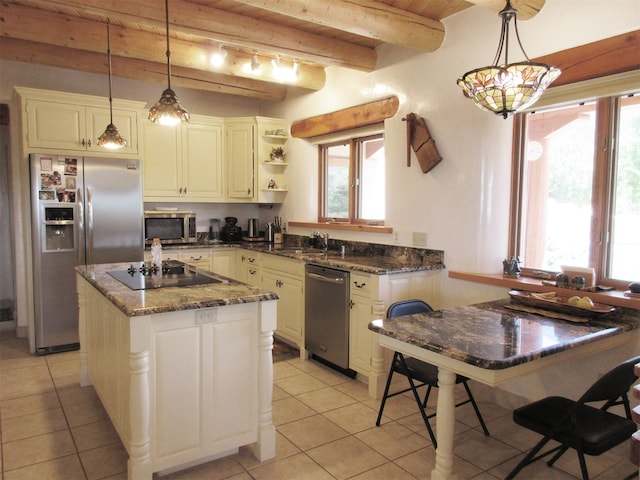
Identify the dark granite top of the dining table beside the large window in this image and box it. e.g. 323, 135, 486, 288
369, 300, 640, 370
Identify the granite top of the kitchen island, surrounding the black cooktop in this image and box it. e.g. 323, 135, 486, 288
75, 263, 278, 317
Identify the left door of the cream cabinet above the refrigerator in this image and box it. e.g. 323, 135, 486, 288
27, 100, 85, 150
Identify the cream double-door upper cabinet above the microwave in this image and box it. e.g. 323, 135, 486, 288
142, 115, 224, 202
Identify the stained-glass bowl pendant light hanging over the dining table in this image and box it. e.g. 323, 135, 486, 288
458, 0, 560, 118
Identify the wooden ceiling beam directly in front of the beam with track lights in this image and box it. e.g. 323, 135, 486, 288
13, 0, 377, 72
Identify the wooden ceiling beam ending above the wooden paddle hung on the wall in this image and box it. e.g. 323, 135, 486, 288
236, 0, 444, 52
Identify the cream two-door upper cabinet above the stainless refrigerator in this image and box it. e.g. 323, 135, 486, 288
16, 87, 143, 156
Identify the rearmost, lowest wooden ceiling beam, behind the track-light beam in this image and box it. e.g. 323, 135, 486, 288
0, 38, 287, 103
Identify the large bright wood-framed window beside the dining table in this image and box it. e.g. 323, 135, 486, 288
510, 94, 640, 286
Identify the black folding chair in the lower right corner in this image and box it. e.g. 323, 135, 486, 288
506, 356, 640, 480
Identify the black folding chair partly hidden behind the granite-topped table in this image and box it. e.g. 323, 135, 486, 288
376, 300, 489, 448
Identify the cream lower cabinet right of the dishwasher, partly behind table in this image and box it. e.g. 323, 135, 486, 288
349, 270, 440, 399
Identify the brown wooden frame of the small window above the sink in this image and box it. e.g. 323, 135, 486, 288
318, 131, 386, 226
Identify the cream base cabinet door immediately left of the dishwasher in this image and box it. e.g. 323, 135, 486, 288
262, 269, 304, 348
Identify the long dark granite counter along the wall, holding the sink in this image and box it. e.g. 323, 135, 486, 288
163, 242, 445, 275
